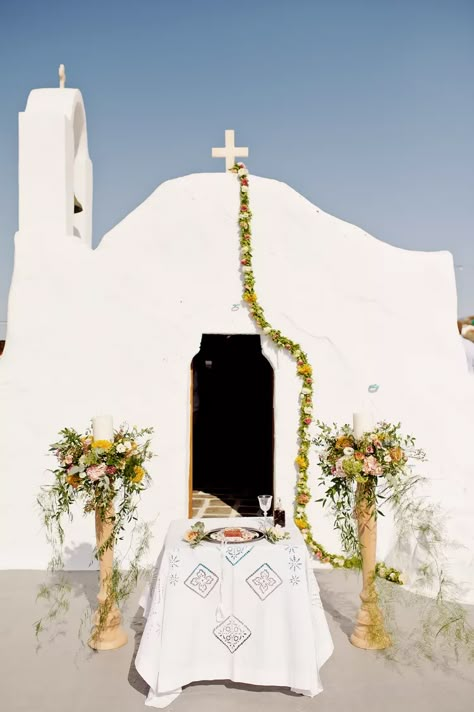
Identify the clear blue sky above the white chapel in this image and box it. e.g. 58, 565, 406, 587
0, 0, 474, 333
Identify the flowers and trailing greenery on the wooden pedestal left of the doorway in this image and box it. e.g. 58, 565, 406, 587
36, 424, 153, 634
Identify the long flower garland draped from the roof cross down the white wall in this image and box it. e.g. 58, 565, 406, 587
231, 163, 350, 568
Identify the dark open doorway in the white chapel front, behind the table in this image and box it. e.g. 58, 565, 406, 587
192, 334, 273, 516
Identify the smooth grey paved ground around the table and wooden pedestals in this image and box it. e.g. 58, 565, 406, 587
0, 570, 474, 712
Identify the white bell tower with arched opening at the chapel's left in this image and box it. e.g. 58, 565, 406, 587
19, 65, 92, 246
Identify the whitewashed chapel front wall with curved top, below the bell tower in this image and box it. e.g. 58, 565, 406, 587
0, 87, 474, 602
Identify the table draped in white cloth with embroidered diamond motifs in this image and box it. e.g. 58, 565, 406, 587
135, 517, 333, 707
